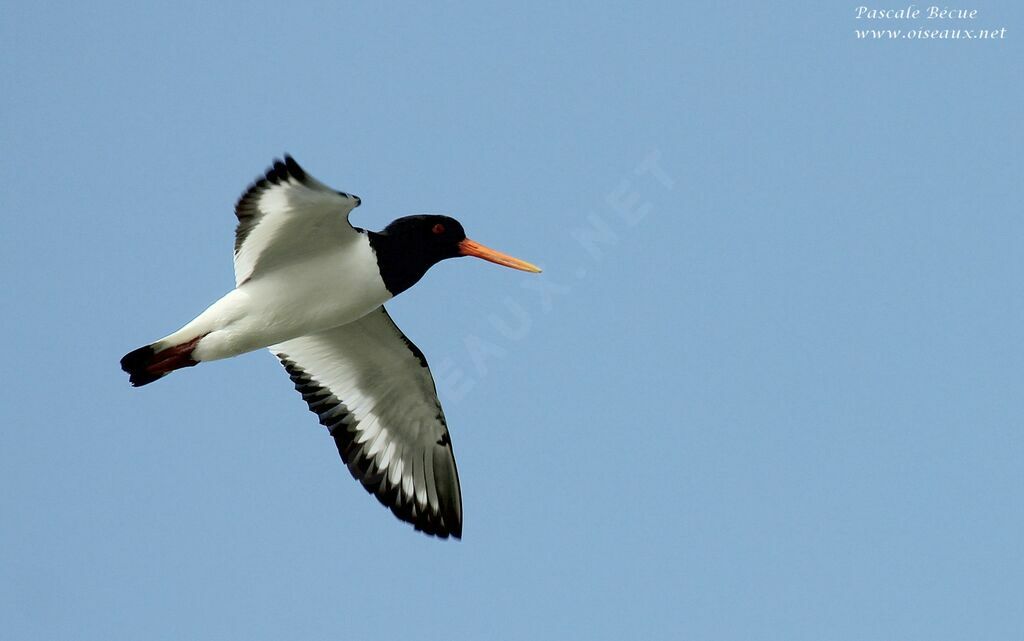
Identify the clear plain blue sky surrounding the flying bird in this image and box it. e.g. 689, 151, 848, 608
0, 2, 1024, 641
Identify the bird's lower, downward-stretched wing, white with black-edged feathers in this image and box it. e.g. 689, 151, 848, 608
270, 307, 462, 537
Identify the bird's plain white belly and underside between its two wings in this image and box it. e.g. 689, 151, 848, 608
182, 237, 391, 360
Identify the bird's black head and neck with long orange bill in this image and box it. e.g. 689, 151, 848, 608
370, 214, 540, 295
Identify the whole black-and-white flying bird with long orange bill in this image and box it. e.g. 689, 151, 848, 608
121, 155, 541, 539
